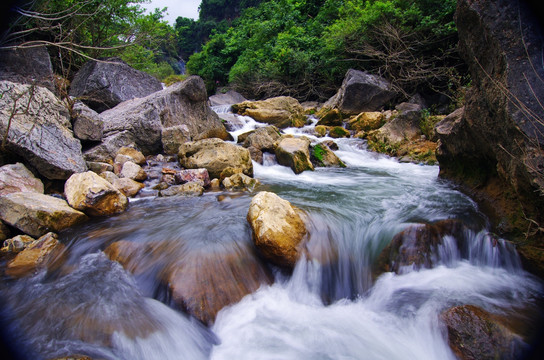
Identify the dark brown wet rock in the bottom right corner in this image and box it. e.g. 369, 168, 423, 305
440, 305, 523, 360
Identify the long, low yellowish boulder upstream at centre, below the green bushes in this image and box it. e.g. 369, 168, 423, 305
232, 96, 306, 129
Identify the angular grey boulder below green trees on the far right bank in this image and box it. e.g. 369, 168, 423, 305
323, 69, 396, 115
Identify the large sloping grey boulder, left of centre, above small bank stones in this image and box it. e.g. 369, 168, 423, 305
85, 76, 229, 161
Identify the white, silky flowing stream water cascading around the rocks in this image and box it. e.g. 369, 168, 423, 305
0, 108, 543, 359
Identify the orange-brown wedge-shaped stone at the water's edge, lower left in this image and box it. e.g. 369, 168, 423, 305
6, 232, 64, 277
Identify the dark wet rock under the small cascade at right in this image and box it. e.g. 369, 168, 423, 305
377, 220, 466, 273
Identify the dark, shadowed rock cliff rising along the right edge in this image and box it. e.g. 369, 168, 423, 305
437, 0, 544, 274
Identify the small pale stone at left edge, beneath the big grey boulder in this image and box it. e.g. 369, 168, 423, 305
0, 163, 43, 196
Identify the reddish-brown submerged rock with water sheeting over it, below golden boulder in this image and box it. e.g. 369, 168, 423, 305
168, 249, 271, 325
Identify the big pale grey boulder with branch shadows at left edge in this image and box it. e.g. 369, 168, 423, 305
0, 81, 87, 179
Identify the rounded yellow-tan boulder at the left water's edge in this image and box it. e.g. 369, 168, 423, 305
64, 171, 128, 216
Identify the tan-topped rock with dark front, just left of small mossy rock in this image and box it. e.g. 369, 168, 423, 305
275, 138, 314, 174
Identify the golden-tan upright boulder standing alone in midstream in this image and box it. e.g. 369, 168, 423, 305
247, 191, 307, 268
